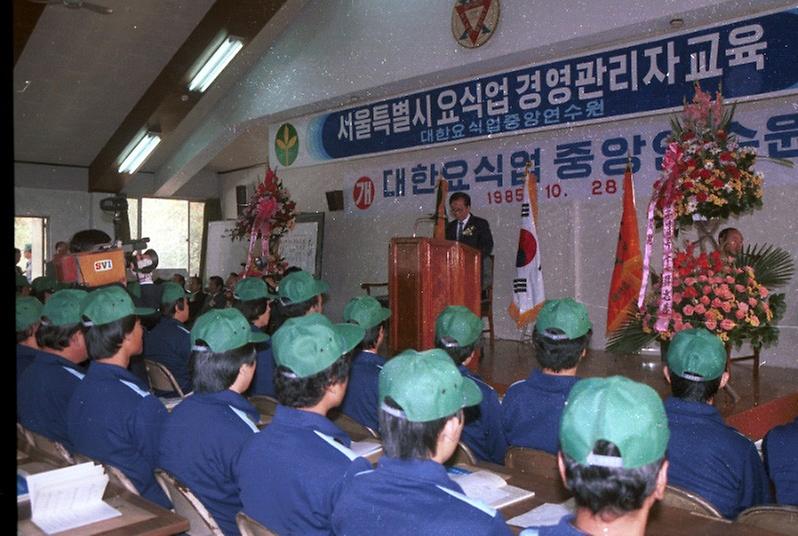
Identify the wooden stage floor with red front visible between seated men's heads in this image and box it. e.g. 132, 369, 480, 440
479, 339, 798, 440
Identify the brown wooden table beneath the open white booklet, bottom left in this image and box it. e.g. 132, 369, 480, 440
17, 449, 190, 536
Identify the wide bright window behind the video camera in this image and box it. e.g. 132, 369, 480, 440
128, 197, 205, 275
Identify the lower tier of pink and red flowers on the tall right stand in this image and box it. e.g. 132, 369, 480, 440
638, 243, 784, 346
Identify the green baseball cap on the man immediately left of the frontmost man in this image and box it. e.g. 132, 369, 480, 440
379, 348, 482, 422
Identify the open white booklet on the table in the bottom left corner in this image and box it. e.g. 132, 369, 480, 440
27, 462, 122, 534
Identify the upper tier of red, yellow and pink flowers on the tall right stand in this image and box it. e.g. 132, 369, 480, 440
654, 84, 763, 227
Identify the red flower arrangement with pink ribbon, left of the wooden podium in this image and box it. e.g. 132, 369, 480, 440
230, 167, 296, 275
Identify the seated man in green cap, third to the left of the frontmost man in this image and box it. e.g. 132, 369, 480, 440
159, 309, 269, 535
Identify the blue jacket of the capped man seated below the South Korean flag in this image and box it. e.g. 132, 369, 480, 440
502, 369, 579, 454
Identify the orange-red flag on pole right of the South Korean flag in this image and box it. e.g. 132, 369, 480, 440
607, 163, 643, 334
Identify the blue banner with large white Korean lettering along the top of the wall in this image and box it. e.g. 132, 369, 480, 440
304, 9, 798, 165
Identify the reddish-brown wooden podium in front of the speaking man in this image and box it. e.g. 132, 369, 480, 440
388, 238, 482, 353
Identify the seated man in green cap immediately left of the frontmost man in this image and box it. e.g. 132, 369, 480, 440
332, 349, 510, 535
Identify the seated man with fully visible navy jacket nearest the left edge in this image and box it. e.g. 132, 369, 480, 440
17, 289, 88, 450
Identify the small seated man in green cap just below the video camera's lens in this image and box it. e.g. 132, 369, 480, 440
143, 281, 192, 396
